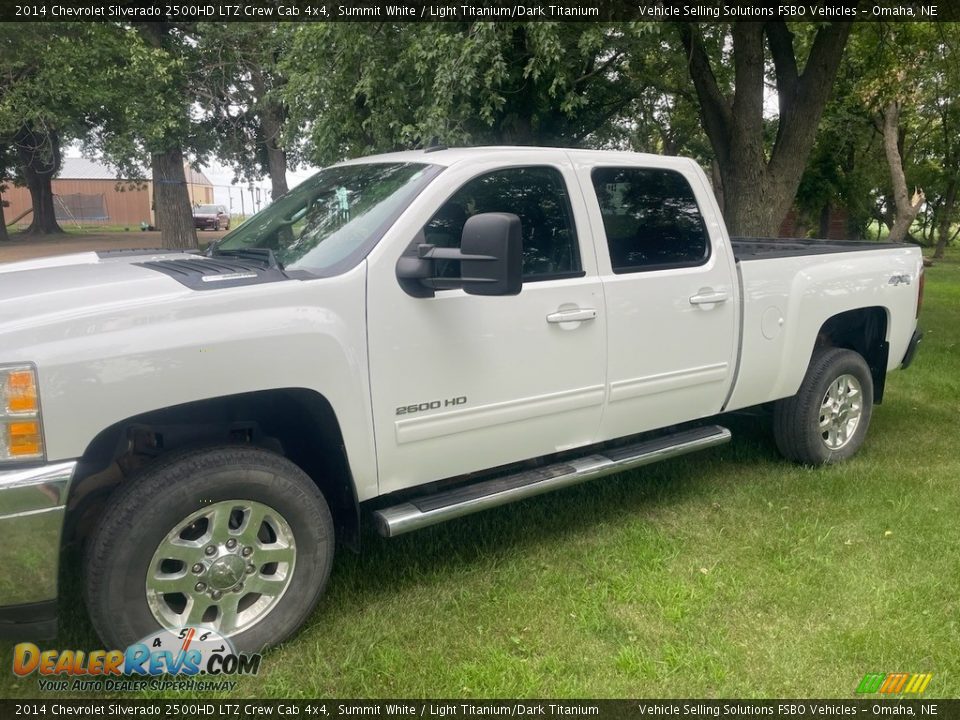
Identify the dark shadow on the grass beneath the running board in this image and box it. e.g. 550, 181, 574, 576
311, 414, 783, 625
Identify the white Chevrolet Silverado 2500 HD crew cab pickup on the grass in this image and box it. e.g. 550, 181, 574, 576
0, 147, 923, 650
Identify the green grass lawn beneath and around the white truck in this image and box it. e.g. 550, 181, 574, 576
0, 260, 960, 698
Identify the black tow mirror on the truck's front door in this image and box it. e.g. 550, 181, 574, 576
397, 213, 523, 297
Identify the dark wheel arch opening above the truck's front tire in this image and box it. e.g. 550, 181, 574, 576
66, 388, 360, 549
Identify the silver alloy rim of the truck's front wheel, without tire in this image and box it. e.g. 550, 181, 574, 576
146, 500, 297, 636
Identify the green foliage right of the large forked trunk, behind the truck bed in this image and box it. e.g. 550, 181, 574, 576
797, 23, 960, 238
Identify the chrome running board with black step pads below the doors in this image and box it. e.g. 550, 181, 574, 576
373, 425, 730, 537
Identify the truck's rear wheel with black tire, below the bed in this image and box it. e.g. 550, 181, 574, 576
773, 348, 873, 465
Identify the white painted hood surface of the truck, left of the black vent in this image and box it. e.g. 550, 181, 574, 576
0, 252, 196, 333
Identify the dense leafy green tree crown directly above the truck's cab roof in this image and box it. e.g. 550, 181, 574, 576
281, 22, 649, 163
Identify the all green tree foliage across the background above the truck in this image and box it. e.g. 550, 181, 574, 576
0, 22, 960, 248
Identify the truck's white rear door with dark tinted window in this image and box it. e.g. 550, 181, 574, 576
578, 156, 739, 439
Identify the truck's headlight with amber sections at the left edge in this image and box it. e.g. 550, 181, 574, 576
0, 365, 43, 462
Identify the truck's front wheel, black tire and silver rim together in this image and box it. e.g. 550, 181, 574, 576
84, 447, 334, 652
